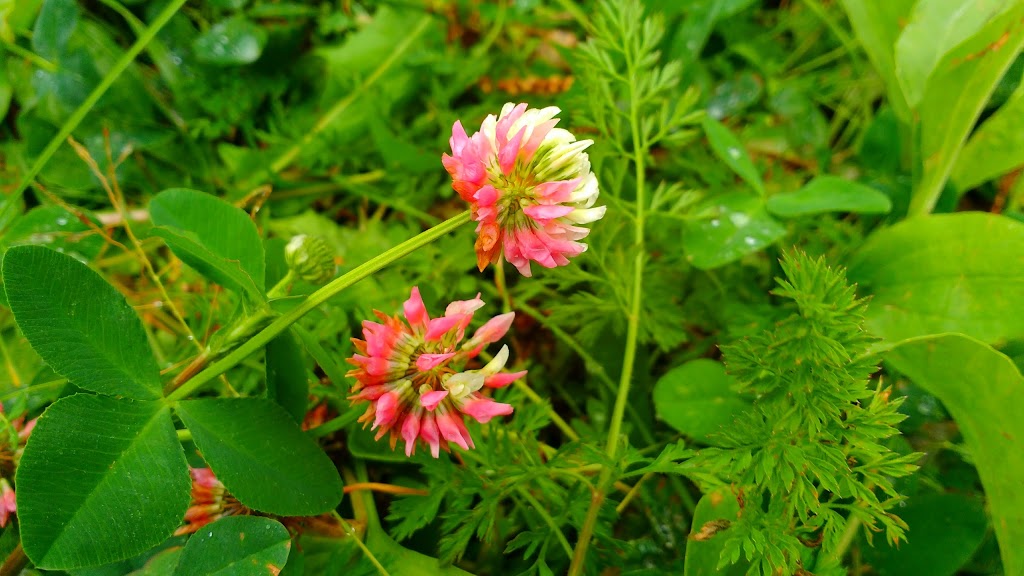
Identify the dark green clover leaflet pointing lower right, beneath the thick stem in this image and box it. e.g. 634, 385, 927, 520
175, 398, 342, 516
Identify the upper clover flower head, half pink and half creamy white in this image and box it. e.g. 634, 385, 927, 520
441, 102, 606, 277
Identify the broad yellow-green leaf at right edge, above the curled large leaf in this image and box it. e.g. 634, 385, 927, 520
848, 212, 1024, 342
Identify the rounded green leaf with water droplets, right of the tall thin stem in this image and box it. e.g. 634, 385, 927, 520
683, 192, 785, 270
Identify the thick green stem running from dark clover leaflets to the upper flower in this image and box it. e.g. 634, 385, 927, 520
167, 211, 470, 402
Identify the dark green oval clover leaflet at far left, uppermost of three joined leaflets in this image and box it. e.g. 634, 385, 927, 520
3, 246, 161, 400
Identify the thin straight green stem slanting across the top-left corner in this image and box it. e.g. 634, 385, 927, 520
0, 0, 185, 221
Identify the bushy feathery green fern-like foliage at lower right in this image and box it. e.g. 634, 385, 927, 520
686, 252, 918, 576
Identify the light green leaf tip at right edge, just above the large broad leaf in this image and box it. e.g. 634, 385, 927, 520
950, 67, 1024, 192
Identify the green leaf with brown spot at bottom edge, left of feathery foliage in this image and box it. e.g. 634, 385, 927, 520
683, 489, 748, 576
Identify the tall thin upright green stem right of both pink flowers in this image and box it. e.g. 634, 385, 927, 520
568, 34, 647, 576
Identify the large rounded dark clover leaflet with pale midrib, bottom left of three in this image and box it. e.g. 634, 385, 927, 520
17, 395, 190, 570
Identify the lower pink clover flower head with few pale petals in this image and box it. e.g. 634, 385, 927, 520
348, 288, 526, 458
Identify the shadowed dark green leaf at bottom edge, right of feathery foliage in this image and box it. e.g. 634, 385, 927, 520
861, 493, 988, 576
